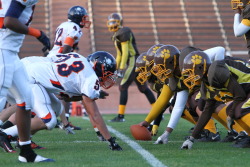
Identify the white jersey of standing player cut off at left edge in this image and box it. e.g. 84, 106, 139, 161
0, 0, 38, 52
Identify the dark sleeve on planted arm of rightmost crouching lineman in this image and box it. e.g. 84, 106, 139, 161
192, 100, 216, 139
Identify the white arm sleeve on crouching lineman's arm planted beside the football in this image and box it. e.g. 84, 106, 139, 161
167, 90, 188, 129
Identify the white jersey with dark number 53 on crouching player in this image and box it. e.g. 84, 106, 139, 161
24, 52, 100, 99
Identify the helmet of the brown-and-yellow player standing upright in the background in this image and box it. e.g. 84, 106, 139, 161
107, 13, 122, 32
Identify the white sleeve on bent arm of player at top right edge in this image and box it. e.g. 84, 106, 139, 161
234, 13, 250, 37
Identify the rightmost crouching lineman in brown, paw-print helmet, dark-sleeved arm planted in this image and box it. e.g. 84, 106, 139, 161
181, 51, 250, 149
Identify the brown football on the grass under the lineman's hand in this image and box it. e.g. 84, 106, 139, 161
130, 124, 152, 140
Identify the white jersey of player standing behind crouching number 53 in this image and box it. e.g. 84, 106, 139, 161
47, 21, 83, 61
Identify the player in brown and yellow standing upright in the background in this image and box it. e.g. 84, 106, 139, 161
107, 13, 155, 122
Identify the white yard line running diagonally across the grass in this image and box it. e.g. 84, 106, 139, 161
83, 117, 167, 167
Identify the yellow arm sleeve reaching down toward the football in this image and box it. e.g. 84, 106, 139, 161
145, 85, 173, 122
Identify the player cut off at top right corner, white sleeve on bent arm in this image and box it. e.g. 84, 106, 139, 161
231, 0, 250, 58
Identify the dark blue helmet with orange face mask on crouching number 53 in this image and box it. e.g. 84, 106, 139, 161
87, 51, 117, 89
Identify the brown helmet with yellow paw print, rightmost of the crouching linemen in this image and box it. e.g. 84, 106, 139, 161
182, 51, 211, 89
